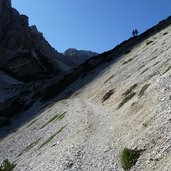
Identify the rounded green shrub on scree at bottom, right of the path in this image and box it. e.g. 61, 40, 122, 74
120, 148, 140, 171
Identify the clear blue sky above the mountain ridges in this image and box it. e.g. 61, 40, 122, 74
12, 0, 171, 52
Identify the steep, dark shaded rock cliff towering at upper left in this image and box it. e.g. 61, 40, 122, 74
0, 0, 71, 81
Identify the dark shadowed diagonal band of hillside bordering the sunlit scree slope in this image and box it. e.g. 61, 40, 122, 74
0, 13, 171, 138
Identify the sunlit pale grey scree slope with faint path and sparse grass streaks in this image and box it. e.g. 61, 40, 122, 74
0, 27, 171, 171
